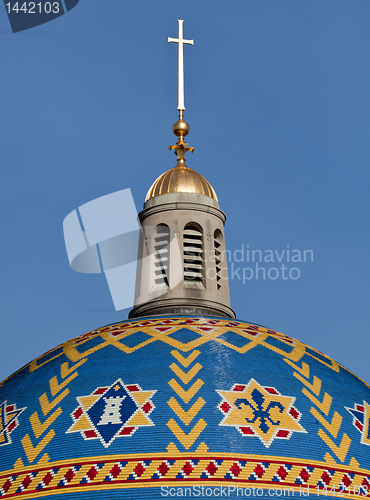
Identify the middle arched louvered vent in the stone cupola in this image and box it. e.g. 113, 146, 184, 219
184, 226, 203, 283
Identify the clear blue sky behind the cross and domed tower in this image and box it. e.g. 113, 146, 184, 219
0, 0, 370, 383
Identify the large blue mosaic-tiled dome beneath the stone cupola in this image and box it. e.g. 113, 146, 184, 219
0, 316, 370, 500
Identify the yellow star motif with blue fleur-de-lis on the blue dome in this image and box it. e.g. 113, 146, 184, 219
217, 379, 306, 447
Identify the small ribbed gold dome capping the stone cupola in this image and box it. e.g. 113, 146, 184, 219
145, 163, 218, 201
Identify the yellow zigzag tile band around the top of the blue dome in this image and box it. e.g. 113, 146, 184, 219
24, 317, 346, 373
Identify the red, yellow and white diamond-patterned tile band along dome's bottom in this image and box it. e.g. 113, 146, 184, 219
0, 454, 370, 499
